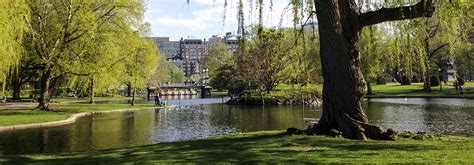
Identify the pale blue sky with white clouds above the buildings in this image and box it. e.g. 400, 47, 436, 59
145, 0, 292, 40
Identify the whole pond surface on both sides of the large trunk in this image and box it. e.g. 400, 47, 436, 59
0, 98, 474, 155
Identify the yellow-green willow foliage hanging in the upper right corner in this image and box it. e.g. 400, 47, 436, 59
410, 1, 472, 91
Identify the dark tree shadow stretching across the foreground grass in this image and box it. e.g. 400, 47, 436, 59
0, 133, 439, 164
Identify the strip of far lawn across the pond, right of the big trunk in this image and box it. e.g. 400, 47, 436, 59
372, 82, 474, 97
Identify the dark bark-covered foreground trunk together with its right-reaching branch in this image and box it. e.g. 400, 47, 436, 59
312, 0, 432, 140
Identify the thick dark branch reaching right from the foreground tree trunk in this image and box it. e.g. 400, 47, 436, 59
359, 0, 435, 28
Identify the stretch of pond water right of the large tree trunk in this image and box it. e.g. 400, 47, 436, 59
364, 99, 474, 135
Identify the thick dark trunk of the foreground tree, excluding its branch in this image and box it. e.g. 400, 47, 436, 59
315, 1, 376, 139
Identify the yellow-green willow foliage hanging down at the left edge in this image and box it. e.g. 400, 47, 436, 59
0, 0, 28, 95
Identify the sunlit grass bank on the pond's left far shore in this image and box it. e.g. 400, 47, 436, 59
0, 103, 159, 126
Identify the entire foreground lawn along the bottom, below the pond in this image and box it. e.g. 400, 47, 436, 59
0, 131, 474, 164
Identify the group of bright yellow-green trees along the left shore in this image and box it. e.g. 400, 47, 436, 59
0, 0, 176, 110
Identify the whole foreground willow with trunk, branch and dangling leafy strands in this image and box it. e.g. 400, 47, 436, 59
192, 0, 462, 139
